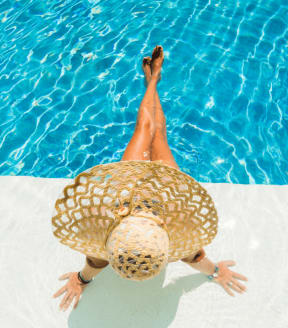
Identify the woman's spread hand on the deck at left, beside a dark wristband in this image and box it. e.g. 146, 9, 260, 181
53, 272, 87, 311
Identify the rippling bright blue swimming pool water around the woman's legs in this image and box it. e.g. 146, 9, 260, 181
0, 0, 288, 184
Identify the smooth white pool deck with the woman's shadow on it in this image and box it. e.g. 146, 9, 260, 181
0, 176, 288, 328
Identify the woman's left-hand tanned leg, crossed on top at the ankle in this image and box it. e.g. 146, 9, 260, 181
121, 47, 164, 161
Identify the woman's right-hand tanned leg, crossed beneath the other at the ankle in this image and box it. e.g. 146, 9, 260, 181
145, 49, 179, 169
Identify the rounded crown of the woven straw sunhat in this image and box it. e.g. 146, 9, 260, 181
106, 216, 169, 281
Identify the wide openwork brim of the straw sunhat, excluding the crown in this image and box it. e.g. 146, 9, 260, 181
52, 161, 218, 262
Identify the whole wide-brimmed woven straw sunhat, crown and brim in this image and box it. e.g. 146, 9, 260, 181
52, 161, 218, 281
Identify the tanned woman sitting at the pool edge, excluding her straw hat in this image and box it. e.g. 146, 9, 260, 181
53, 46, 248, 311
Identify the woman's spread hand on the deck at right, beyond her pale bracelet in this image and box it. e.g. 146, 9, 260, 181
213, 260, 248, 296
